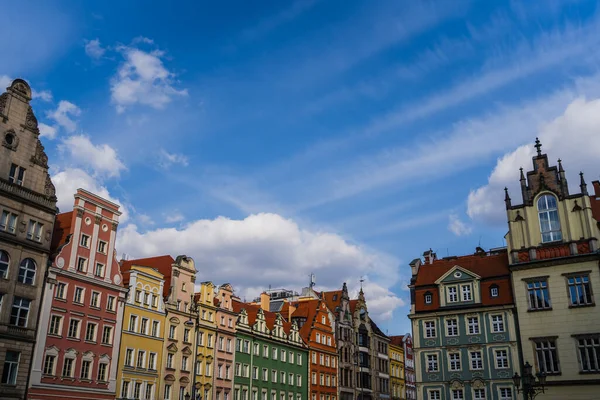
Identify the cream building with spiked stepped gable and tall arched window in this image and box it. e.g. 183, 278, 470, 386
505, 140, 600, 399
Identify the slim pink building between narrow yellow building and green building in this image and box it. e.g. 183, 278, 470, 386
213, 283, 237, 400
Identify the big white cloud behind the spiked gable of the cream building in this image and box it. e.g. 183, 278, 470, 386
467, 98, 600, 224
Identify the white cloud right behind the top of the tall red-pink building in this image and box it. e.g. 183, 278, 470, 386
52, 168, 129, 223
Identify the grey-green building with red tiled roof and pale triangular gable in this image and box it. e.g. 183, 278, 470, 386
409, 248, 519, 400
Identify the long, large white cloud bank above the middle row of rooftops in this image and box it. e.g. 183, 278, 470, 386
118, 213, 404, 319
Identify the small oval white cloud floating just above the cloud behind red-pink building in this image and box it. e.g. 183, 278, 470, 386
59, 135, 125, 177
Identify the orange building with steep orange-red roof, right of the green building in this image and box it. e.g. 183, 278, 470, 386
291, 299, 338, 400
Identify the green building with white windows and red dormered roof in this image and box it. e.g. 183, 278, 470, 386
232, 300, 308, 400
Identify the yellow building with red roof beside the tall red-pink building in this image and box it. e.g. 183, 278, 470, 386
117, 259, 165, 400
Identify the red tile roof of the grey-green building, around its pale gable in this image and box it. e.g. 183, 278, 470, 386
415, 251, 510, 286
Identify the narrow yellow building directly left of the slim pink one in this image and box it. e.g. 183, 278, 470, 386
194, 282, 219, 399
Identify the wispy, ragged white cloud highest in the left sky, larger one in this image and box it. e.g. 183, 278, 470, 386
110, 42, 188, 113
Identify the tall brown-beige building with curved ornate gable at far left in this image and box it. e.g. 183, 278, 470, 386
0, 79, 58, 399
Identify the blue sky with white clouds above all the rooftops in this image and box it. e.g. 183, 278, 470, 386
0, 0, 600, 335
